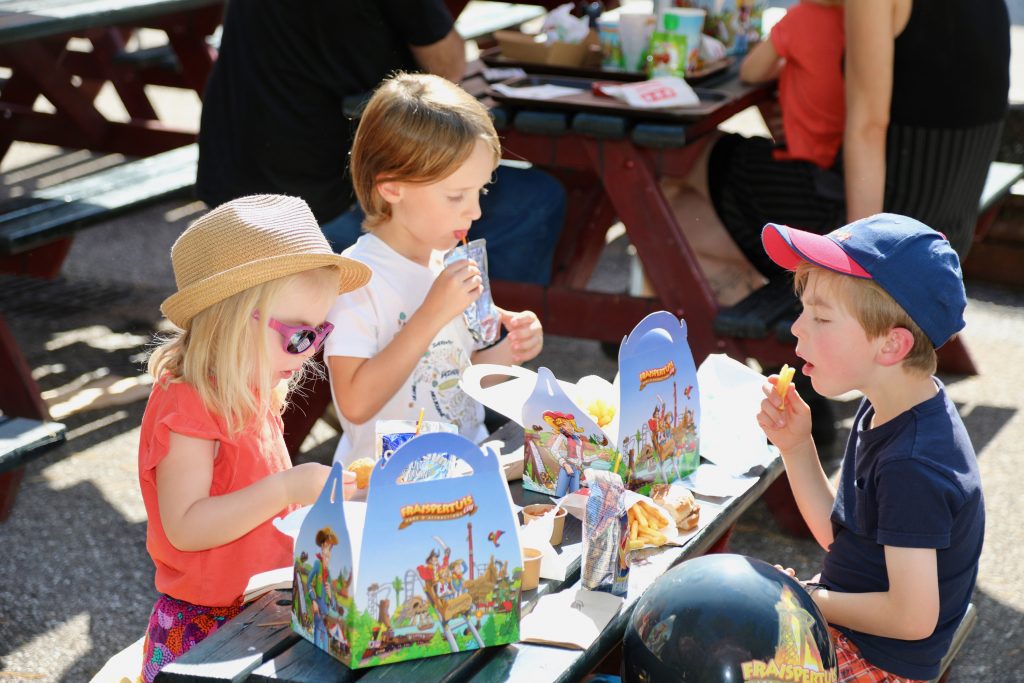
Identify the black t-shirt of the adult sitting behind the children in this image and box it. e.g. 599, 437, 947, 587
197, 0, 454, 222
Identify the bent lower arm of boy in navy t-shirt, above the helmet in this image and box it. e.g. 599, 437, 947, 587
812, 546, 939, 640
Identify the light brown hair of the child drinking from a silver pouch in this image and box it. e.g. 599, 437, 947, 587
350, 74, 502, 229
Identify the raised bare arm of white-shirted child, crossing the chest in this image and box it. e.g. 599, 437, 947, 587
328, 260, 483, 424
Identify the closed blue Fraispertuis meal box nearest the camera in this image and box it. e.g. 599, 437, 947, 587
292, 433, 522, 669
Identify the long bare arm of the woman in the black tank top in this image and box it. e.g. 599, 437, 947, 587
843, 0, 897, 221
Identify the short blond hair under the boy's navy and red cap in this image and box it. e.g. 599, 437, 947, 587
794, 261, 937, 376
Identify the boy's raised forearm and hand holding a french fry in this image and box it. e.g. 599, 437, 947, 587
758, 375, 836, 550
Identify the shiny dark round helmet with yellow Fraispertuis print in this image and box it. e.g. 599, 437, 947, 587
623, 555, 838, 683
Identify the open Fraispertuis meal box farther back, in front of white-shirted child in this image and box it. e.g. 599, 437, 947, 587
462, 311, 700, 498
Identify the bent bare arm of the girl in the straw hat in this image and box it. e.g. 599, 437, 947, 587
157, 432, 331, 551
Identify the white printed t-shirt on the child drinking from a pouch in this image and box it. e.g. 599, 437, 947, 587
324, 233, 487, 465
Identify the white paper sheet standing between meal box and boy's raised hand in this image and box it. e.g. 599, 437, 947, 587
697, 353, 774, 474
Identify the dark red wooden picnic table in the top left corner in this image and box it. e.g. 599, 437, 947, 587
0, 0, 223, 159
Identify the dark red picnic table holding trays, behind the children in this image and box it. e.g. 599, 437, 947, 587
476, 62, 796, 366
